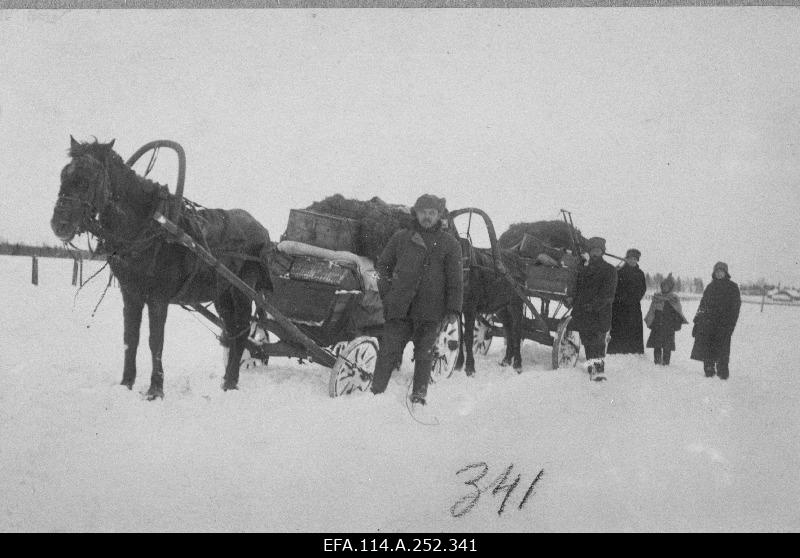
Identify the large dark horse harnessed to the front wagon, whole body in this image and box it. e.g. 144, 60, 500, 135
50, 137, 270, 400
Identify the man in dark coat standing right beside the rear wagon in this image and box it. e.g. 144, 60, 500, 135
572, 237, 617, 380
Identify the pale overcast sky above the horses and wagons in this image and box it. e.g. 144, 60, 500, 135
0, 8, 800, 286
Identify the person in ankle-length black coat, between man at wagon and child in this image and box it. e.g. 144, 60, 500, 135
608, 248, 647, 355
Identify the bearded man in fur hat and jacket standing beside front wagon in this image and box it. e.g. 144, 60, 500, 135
372, 194, 463, 405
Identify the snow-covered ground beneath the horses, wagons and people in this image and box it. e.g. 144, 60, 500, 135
0, 256, 800, 533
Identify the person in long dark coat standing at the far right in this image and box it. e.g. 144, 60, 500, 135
691, 262, 742, 380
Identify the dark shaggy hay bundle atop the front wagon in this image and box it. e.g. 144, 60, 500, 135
306, 194, 414, 261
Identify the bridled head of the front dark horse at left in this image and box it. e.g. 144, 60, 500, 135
50, 136, 114, 242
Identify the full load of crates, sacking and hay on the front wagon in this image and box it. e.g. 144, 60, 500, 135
269, 194, 413, 338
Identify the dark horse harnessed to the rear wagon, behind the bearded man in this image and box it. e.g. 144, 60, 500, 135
456, 248, 525, 376
